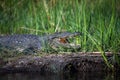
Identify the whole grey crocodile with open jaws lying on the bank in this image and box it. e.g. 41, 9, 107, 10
0, 32, 80, 53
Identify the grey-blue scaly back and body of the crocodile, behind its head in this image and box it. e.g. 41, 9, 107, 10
0, 34, 41, 51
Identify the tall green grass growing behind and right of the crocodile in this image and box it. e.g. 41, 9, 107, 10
0, 0, 120, 52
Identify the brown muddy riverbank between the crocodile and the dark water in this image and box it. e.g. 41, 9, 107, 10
0, 52, 120, 73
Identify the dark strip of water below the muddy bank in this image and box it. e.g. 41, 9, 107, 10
0, 72, 120, 80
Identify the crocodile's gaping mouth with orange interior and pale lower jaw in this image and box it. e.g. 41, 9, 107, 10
51, 35, 80, 50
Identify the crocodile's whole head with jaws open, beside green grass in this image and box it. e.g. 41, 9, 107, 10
49, 32, 81, 50
